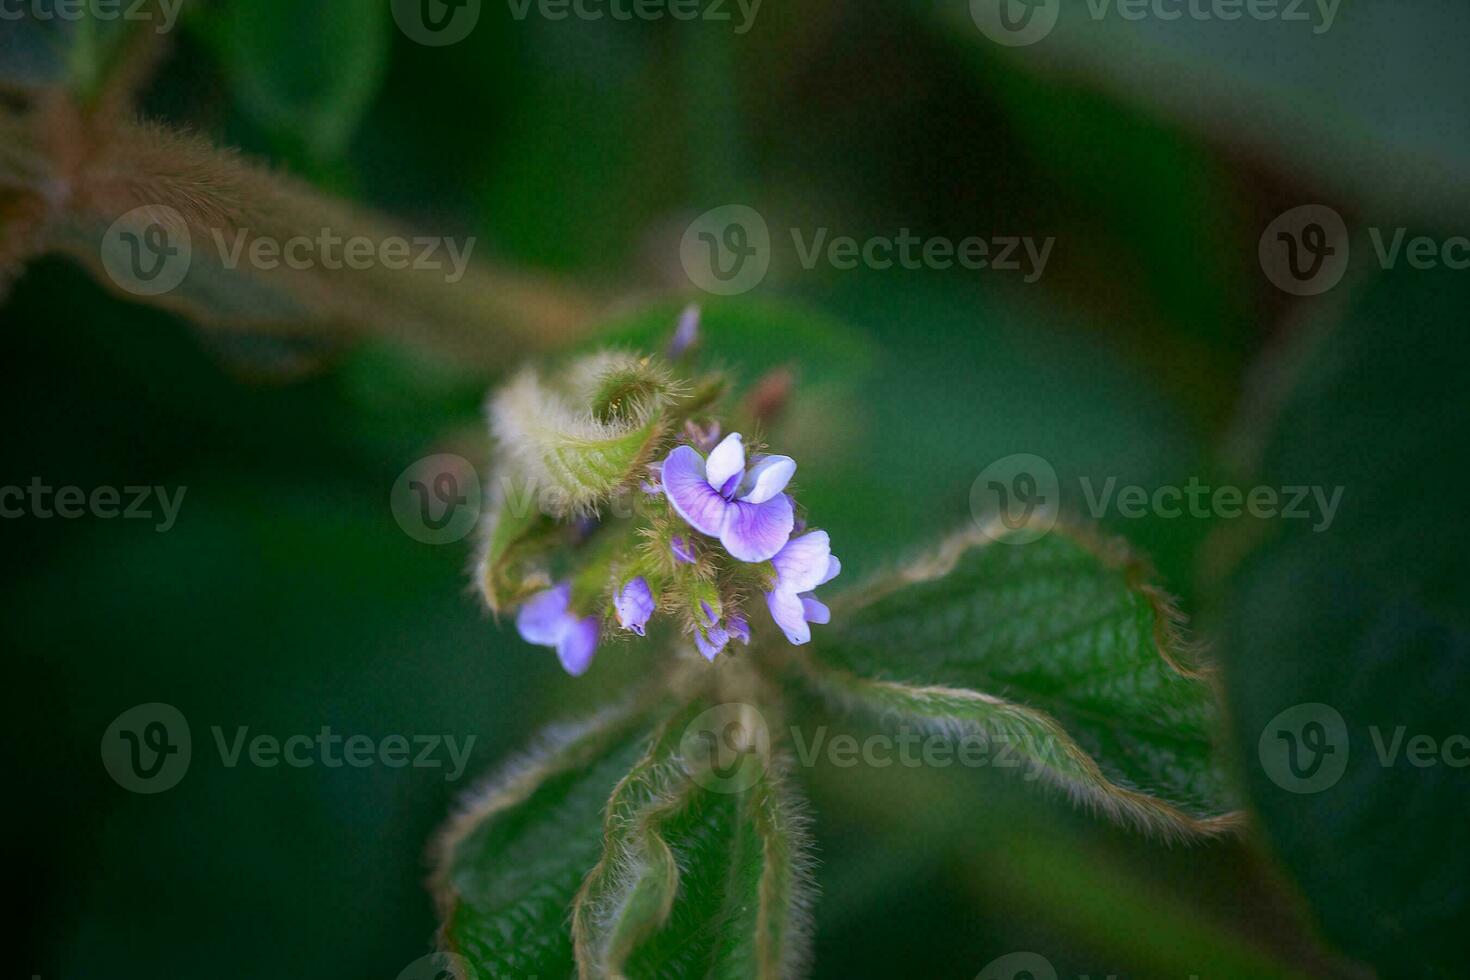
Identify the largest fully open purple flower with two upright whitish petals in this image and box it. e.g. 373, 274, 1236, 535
663, 432, 797, 561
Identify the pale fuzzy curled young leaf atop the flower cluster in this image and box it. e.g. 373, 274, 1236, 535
491, 354, 673, 516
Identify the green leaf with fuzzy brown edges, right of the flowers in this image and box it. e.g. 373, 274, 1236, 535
804, 529, 1236, 836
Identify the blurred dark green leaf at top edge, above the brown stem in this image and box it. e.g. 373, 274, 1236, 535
204, 0, 390, 160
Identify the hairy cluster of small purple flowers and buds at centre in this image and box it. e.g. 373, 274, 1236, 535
481, 311, 842, 674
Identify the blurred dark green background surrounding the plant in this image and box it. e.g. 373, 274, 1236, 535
0, 0, 1470, 980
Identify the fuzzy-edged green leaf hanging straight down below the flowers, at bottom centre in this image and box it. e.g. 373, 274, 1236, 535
573, 702, 809, 979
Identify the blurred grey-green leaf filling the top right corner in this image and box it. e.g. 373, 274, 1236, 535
929, 0, 1470, 220
